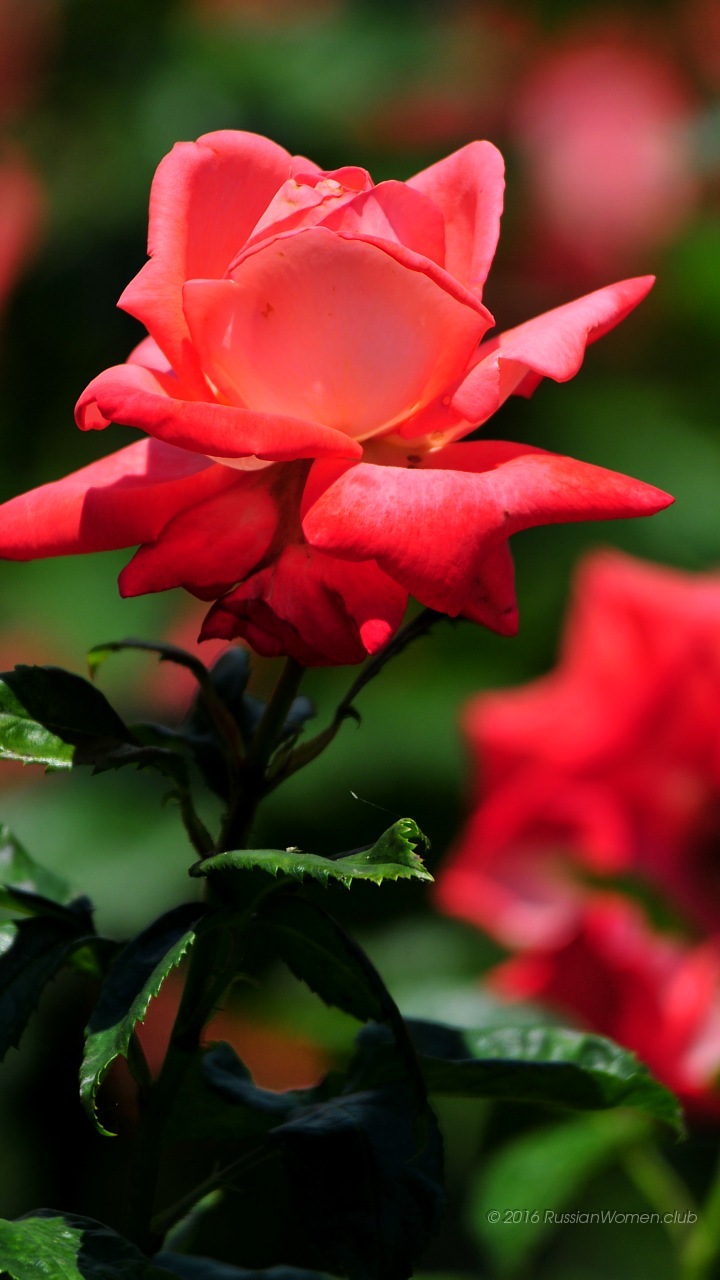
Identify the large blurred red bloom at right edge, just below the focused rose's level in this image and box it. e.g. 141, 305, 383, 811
438, 550, 720, 947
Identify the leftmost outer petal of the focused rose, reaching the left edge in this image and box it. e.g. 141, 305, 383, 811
0, 440, 234, 559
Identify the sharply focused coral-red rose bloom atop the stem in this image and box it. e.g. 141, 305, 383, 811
0, 132, 670, 664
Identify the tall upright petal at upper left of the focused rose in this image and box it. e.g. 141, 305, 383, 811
119, 129, 291, 388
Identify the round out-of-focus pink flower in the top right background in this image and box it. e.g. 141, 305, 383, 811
514, 23, 700, 275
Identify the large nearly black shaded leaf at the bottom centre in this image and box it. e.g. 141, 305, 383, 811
273, 1083, 445, 1280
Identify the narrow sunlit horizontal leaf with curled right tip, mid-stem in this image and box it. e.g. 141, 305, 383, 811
191, 818, 433, 888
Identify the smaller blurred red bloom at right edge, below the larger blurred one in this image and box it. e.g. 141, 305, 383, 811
488, 893, 720, 1119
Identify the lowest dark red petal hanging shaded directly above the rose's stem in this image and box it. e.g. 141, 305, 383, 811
201, 544, 407, 667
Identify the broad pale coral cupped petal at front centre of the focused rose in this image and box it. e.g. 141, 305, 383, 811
184, 228, 486, 436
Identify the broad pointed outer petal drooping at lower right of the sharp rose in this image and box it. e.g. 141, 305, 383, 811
302, 440, 671, 614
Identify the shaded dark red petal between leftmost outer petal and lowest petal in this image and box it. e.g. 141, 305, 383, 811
119, 472, 278, 600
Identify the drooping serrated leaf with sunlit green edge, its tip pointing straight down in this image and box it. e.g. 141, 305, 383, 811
79, 902, 204, 1137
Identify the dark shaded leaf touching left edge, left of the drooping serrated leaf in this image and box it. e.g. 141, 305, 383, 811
0, 910, 94, 1059
